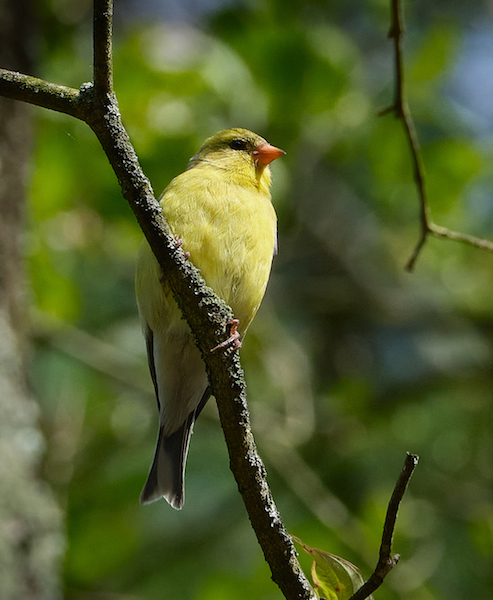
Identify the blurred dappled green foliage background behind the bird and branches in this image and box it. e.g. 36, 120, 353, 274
26, 0, 493, 600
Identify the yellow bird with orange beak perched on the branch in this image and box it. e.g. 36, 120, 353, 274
136, 129, 284, 509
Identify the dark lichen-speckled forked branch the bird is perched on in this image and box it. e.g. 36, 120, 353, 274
0, 0, 315, 600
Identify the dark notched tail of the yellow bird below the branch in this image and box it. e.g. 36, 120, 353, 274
140, 387, 211, 510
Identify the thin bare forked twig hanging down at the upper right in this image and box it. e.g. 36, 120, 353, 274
380, 0, 493, 271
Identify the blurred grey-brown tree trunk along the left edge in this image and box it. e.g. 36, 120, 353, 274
0, 0, 63, 600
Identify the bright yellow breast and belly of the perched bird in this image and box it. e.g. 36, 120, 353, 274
160, 164, 276, 334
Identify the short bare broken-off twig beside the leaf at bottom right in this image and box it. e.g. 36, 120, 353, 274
350, 452, 419, 600
